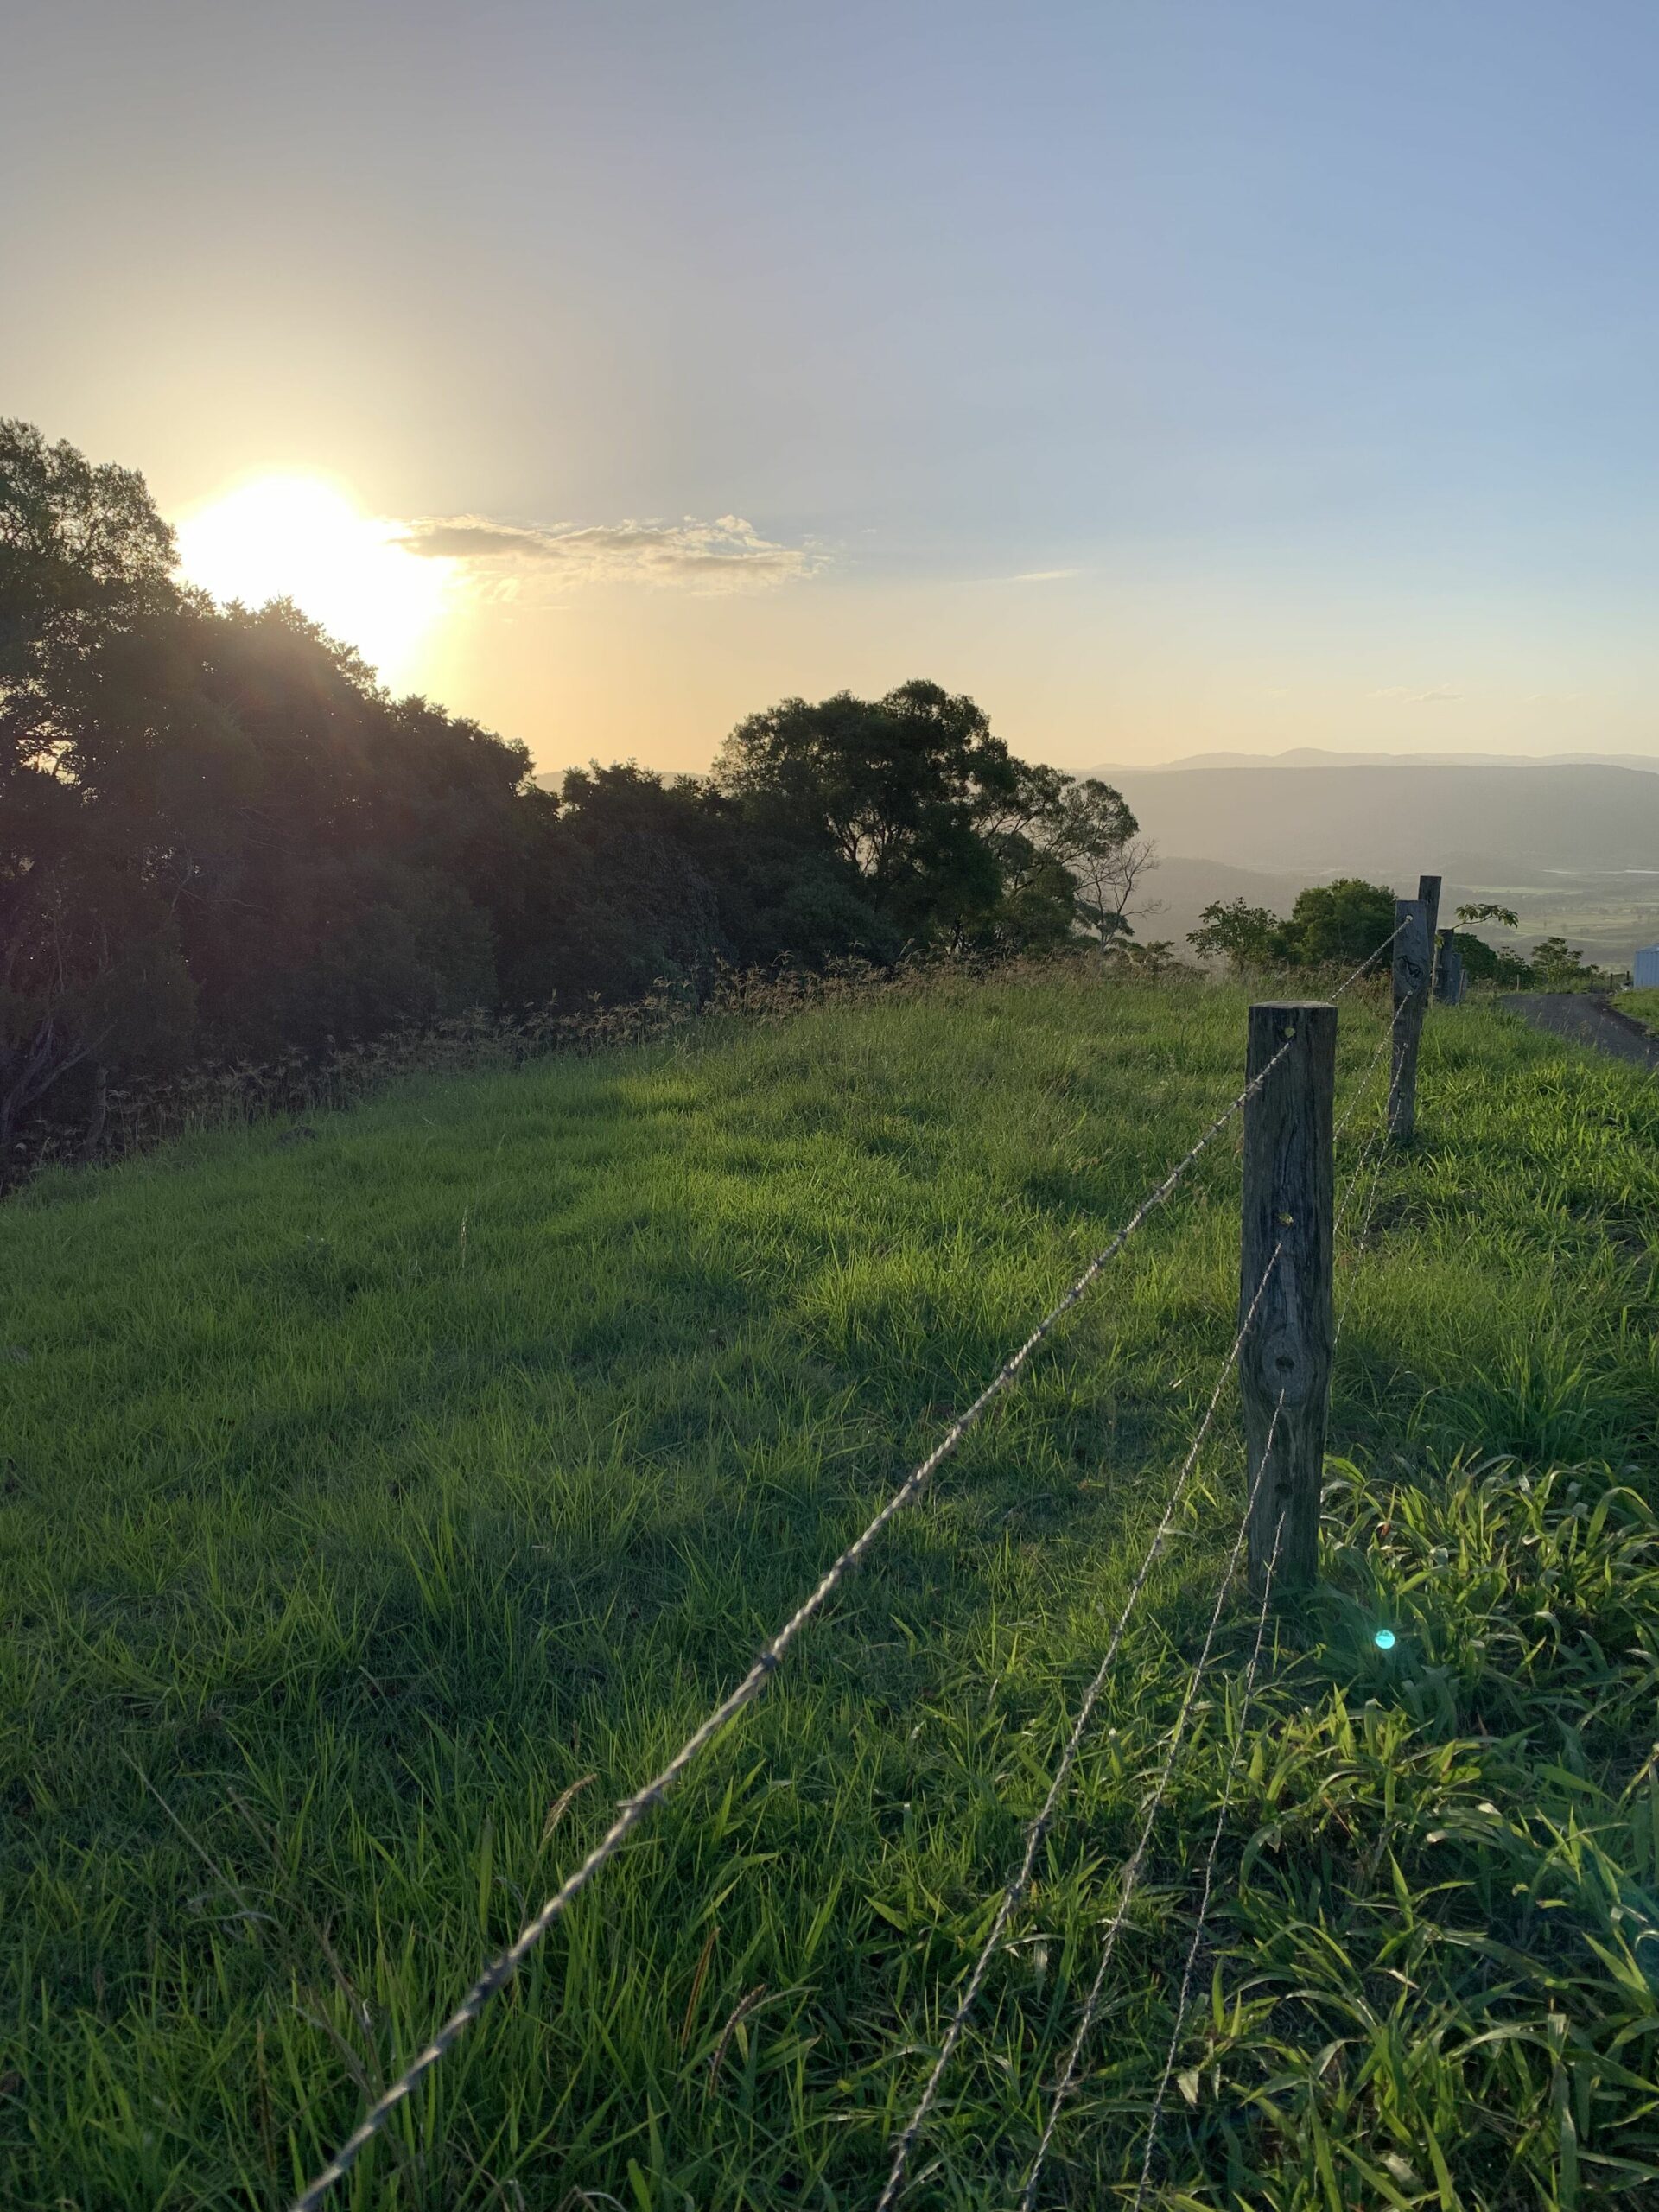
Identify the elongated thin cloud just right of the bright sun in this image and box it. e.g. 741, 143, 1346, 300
403, 515, 823, 591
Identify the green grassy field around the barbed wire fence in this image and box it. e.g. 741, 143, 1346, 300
0, 976, 1659, 2212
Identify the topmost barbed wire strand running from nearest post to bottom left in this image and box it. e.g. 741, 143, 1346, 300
292, 1038, 1294, 2212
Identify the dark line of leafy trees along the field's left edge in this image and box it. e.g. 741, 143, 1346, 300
0, 423, 1153, 1153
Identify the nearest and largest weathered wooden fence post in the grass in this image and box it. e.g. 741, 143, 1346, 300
1239, 1000, 1336, 1591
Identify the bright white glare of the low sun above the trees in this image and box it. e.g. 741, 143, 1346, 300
177, 475, 454, 688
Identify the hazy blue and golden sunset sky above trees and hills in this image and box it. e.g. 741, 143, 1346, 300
0, 0, 1659, 770
